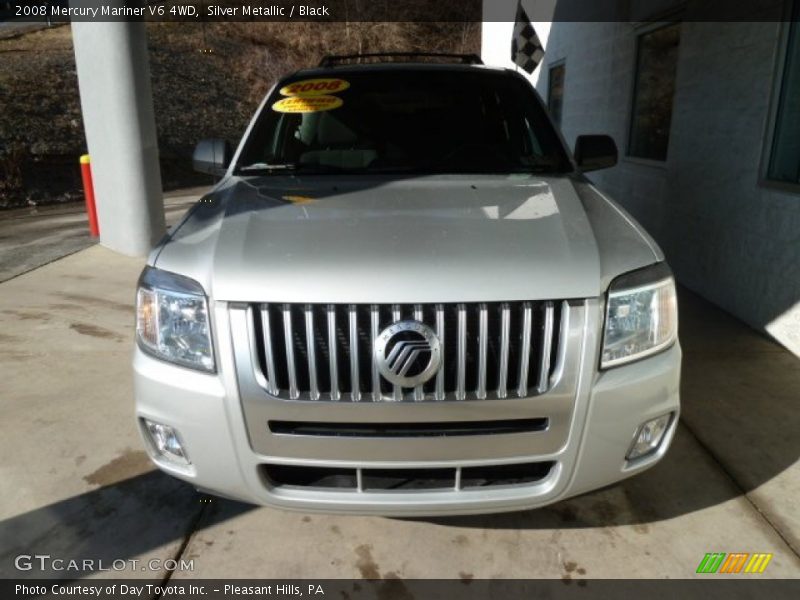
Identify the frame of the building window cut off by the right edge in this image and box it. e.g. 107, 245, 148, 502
758, 0, 800, 194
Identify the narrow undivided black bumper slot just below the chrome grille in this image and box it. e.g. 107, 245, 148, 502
269, 418, 549, 438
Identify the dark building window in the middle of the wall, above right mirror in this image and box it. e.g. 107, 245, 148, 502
628, 23, 681, 160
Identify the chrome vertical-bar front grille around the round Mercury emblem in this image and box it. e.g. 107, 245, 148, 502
251, 301, 565, 402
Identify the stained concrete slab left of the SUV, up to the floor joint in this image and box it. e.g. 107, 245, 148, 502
0, 246, 198, 577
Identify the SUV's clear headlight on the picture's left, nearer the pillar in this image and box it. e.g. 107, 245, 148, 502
136, 267, 214, 371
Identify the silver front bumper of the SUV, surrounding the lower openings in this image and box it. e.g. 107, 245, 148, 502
133, 300, 681, 516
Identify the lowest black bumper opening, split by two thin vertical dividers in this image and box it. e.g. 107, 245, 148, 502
261, 461, 555, 493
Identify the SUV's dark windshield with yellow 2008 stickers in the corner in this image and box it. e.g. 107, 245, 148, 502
237, 69, 571, 174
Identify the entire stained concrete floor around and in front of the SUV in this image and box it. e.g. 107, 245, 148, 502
0, 218, 800, 581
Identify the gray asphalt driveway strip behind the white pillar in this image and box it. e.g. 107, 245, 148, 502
0, 189, 201, 281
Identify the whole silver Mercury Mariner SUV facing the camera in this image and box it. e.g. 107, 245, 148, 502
133, 55, 681, 515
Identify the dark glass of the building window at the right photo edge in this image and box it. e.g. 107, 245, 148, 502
767, 7, 800, 183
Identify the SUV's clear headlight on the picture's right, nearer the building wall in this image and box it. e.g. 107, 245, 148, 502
600, 262, 678, 369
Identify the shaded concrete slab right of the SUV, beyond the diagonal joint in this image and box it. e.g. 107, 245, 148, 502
681, 292, 800, 554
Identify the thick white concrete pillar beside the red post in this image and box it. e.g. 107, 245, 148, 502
72, 21, 165, 256
